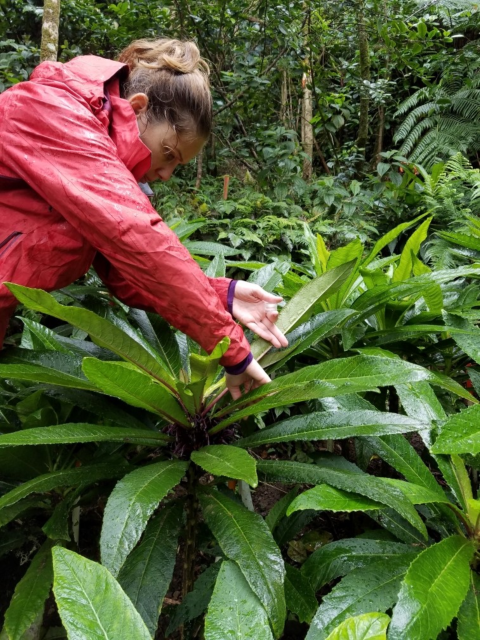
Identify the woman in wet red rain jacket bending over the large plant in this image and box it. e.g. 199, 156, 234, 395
0, 39, 287, 398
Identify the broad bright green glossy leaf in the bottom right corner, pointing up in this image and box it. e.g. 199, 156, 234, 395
389, 535, 474, 640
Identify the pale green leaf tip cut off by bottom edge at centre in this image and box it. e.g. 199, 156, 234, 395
205, 562, 273, 640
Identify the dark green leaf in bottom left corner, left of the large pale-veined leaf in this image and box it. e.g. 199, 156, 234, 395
5, 541, 53, 640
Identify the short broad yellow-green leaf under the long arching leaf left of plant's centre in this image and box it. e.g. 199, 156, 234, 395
83, 358, 190, 426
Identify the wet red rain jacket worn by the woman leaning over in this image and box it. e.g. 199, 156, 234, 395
0, 56, 250, 366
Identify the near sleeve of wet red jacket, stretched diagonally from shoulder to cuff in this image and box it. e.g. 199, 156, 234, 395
0, 82, 250, 366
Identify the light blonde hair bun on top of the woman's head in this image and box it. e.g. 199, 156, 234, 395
119, 38, 209, 75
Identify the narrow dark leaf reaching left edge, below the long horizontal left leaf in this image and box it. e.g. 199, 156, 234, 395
0, 462, 128, 509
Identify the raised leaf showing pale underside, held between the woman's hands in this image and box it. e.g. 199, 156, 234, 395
252, 260, 355, 360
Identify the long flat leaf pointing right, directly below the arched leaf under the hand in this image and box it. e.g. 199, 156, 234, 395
237, 411, 428, 447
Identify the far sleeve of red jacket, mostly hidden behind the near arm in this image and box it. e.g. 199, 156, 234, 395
93, 253, 231, 312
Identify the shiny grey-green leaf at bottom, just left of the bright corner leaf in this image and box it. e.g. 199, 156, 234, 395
305, 556, 411, 640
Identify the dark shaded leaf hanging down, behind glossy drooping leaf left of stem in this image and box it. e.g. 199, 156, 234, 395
118, 505, 182, 636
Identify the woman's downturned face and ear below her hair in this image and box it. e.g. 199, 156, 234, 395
127, 93, 205, 182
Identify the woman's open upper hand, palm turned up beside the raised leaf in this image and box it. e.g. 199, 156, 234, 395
232, 280, 288, 349
